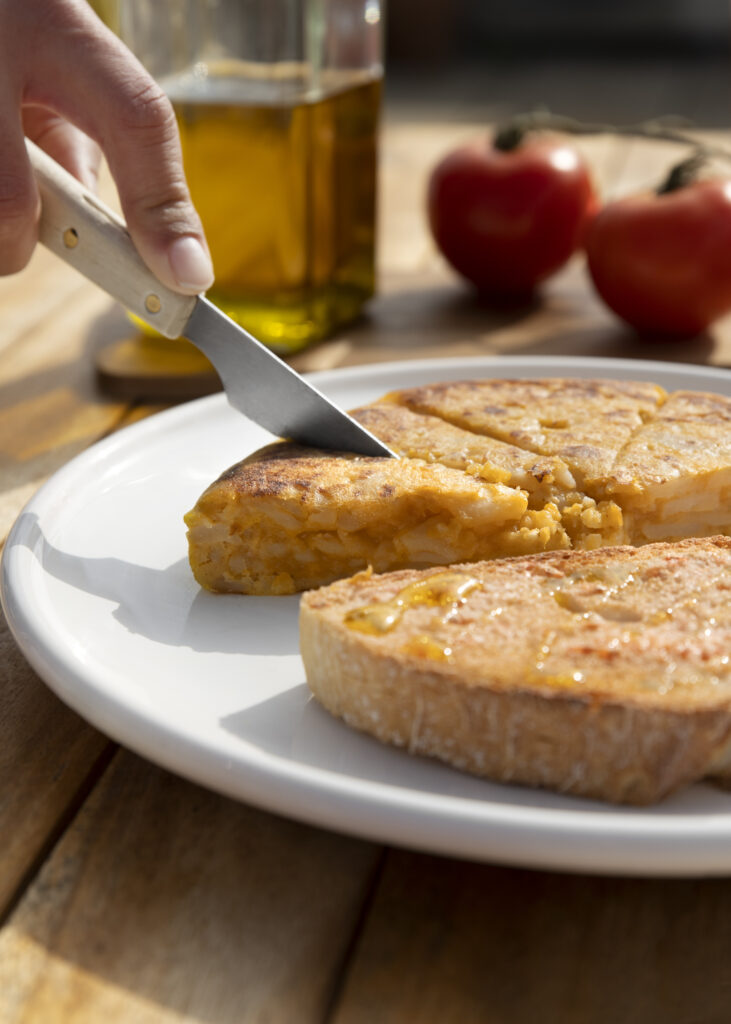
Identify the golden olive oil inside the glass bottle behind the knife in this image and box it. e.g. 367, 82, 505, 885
166, 76, 381, 352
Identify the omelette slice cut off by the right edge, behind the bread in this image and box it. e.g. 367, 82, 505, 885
605, 391, 731, 544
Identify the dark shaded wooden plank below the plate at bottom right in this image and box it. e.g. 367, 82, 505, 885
331, 851, 731, 1024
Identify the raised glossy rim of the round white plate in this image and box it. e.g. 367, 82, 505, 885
5, 354, 731, 876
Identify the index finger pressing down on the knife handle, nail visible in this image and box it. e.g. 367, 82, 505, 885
27, 0, 213, 292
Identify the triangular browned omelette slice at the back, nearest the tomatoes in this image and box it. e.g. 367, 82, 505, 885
387, 378, 665, 494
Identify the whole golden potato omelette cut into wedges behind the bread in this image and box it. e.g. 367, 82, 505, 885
186, 379, 731, 594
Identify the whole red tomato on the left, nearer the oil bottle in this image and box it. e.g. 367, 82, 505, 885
428, 135, 596, 298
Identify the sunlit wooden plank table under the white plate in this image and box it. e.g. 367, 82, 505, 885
0, 124, 731, 1024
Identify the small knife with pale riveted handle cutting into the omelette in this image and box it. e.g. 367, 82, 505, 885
26, 139, 394, 457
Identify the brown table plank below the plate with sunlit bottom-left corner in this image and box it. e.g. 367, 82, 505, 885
0, 753, 379, 1024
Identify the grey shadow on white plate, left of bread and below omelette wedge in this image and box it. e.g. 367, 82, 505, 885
9, 512, 299, 655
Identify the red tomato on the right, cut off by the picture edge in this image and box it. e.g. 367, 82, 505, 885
587, 179, 731, 336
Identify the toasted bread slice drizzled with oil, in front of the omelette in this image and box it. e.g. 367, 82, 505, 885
300, 537, 731, 804
